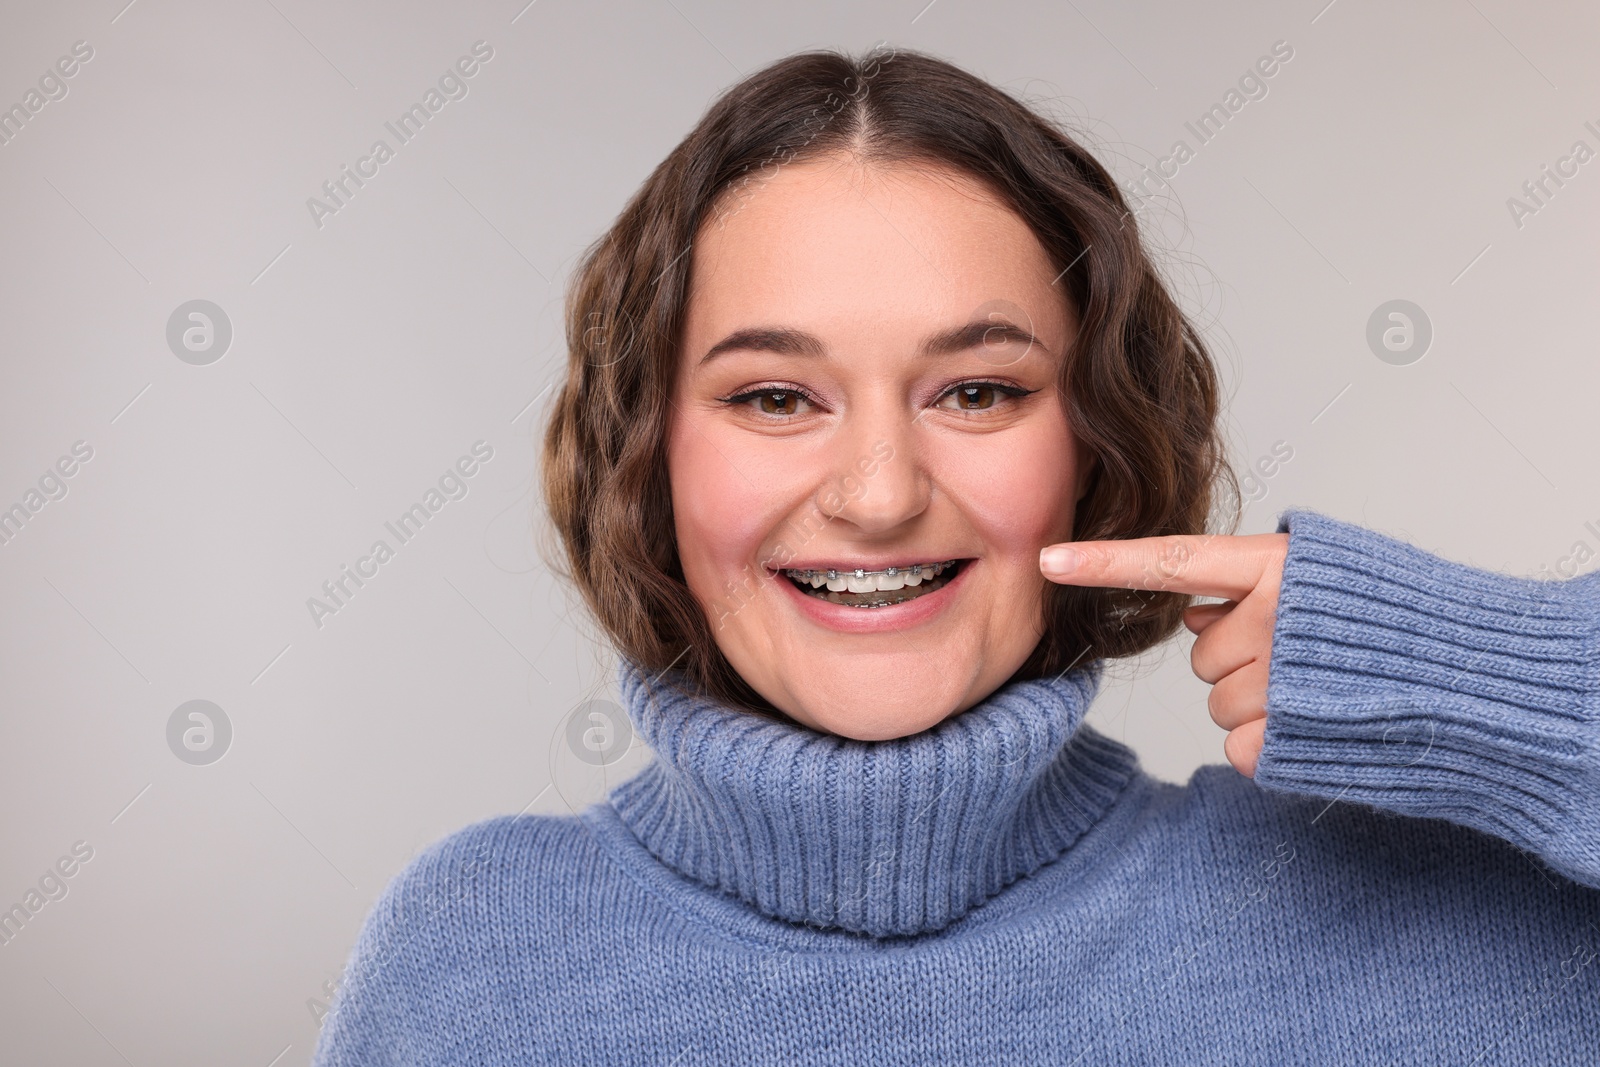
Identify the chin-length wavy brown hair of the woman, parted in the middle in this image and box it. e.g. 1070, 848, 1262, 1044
542, 50, 1238, 713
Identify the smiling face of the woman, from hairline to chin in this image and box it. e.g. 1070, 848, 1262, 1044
667, 157, 1088, 741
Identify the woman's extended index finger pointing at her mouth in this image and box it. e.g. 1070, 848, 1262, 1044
1038, 534, 1285, 600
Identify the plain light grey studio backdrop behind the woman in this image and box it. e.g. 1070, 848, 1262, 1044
0, 0, 1600, 1067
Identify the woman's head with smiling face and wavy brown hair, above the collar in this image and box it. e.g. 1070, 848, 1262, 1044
546, 51, 1237, 739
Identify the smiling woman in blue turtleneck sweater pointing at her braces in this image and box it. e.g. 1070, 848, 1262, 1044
317, 51, 1600, 1065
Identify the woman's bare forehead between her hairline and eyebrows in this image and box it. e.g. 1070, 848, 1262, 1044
686, 157, 1067, 339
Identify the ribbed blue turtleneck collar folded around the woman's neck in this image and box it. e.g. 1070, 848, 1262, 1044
610, 661, 1138, 937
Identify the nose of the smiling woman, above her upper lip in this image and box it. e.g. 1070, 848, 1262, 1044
816, 404, 933, 534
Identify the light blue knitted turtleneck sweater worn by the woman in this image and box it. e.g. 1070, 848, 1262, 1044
315, 510, 1600, 1067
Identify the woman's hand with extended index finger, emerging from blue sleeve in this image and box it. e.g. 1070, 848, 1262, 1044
1038, 534, 1290, 776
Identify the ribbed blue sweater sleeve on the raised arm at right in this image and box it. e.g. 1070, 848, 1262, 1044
1254, 510, 1600, 888
